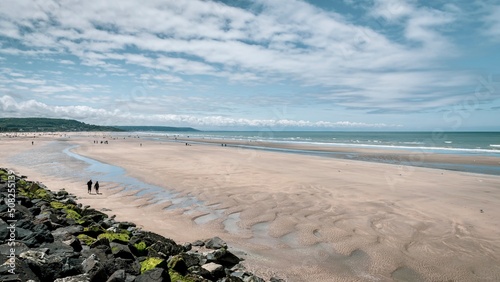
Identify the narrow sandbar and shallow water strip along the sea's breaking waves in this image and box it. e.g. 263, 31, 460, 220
170, 137, 500, 175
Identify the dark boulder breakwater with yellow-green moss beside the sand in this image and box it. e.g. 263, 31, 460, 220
0, 169, 283, 282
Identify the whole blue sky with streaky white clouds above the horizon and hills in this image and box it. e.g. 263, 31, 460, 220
0, 0, 500, 131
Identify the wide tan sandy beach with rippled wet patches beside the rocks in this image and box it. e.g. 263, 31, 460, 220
0, 133, 500, 281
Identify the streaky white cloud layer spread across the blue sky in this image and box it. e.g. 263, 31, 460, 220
0, 0, 500, 128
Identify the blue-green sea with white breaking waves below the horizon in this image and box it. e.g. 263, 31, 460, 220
142, 131, 500, 157
